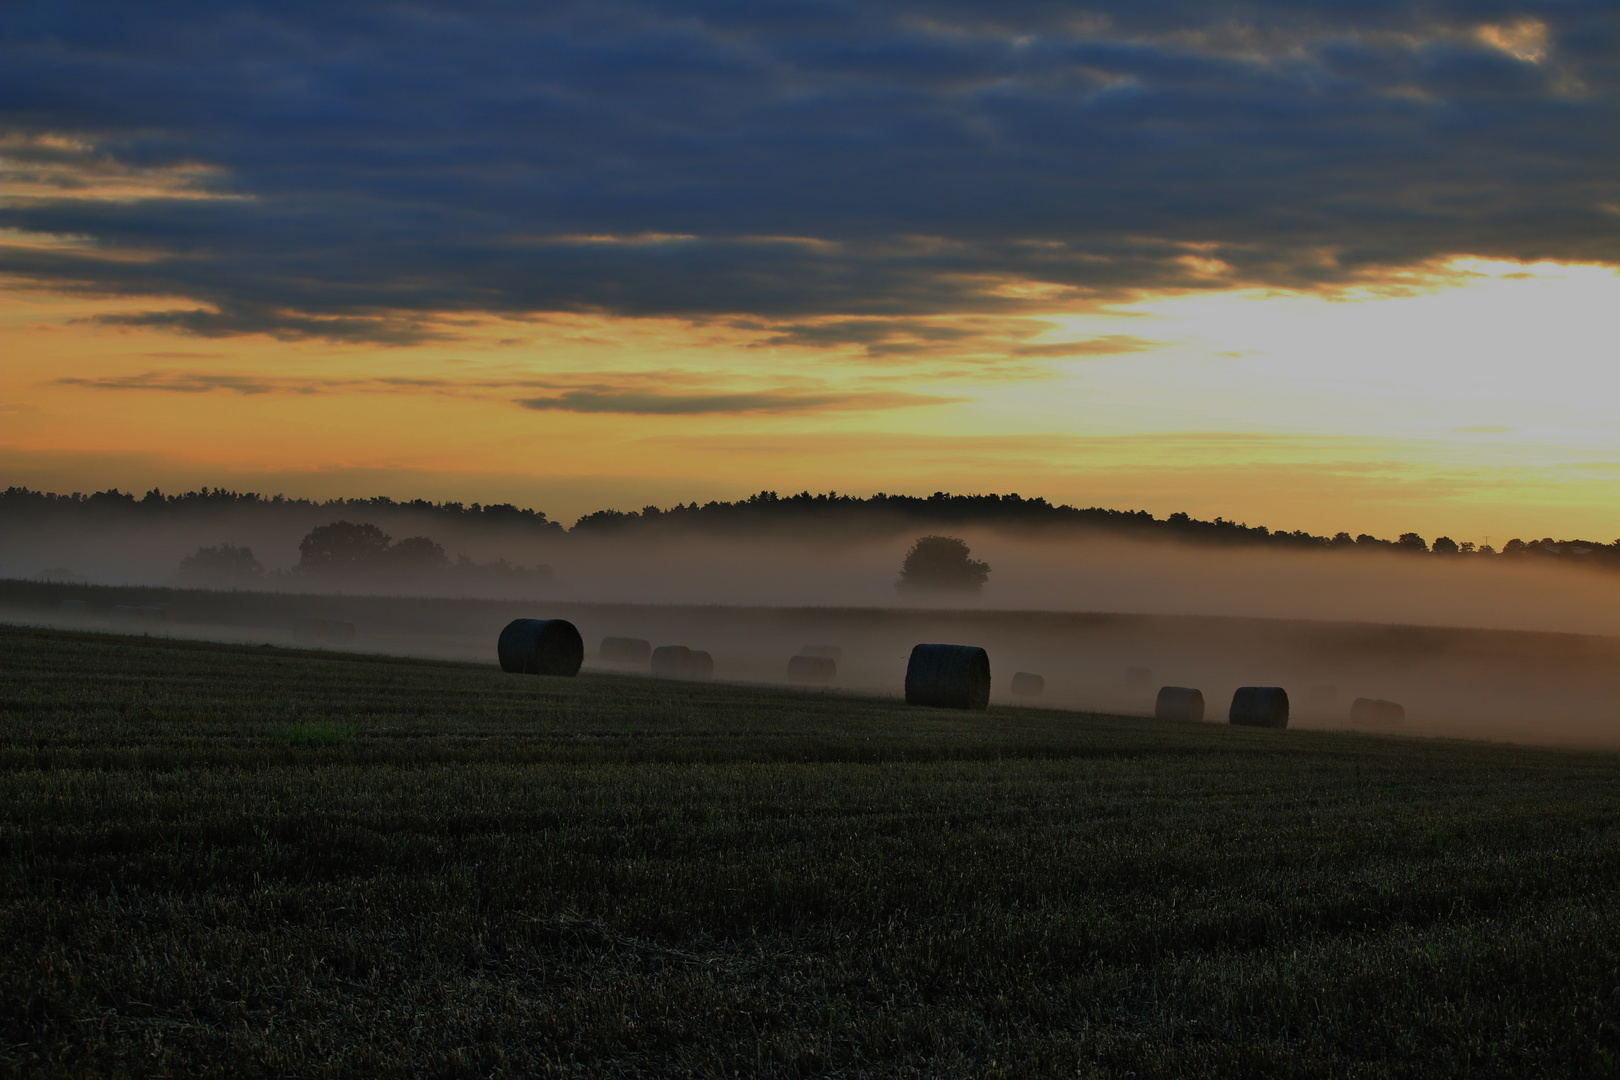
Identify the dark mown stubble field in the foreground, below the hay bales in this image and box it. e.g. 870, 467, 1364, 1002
0, 627, 1620, 1077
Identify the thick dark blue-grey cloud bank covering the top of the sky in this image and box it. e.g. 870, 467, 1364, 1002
0, 0, 1620, 344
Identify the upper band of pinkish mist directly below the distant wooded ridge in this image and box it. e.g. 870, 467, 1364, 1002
0, 508, 1620, 635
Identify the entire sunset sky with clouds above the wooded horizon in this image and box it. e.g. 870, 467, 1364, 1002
0, 0, 1620, 546
